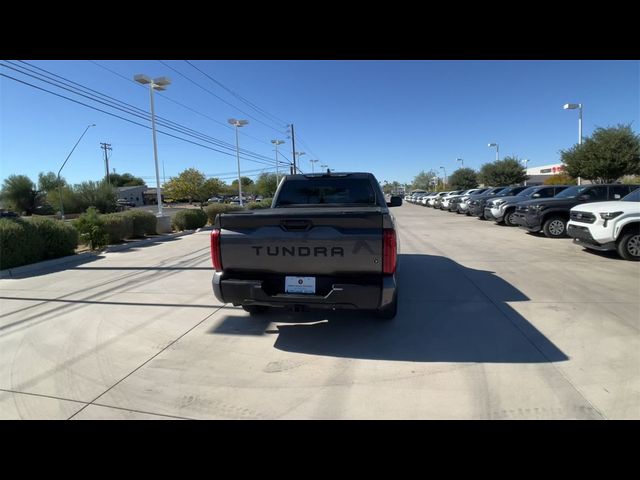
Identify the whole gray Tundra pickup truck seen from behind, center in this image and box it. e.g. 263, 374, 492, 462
211, 172, 402, 319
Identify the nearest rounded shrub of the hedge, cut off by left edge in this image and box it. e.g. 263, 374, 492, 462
0, 218, 44, 269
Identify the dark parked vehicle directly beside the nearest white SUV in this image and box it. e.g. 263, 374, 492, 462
513, 184, 640, 238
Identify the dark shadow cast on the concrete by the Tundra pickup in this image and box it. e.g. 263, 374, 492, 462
210, 255, 568, 363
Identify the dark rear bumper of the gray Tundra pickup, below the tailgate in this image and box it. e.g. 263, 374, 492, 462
212, 272, 397, 310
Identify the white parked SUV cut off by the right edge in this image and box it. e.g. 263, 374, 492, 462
567, 188, 640, 260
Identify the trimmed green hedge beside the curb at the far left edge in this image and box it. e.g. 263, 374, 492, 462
0, 218, 78, 269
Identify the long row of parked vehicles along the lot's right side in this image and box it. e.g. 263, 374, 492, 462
405, 184, 640, 260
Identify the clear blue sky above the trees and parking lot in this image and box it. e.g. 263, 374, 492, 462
0, 60, 640, 186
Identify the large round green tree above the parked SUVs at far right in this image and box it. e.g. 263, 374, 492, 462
560, 125, 640, 183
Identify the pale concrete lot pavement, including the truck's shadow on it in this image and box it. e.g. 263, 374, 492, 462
0, 204, 640, 419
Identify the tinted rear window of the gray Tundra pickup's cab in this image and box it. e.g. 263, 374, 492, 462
275, 177, 377, 207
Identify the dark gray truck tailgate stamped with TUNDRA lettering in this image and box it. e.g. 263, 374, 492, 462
217, 207, 383, 275
